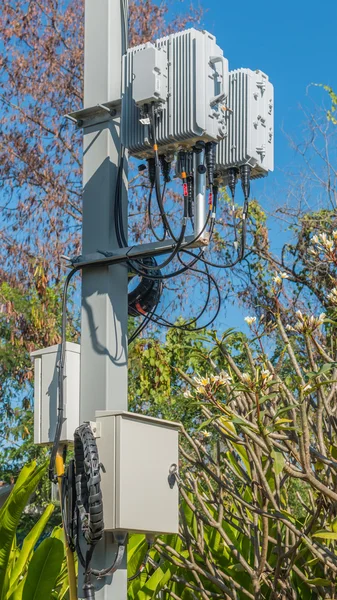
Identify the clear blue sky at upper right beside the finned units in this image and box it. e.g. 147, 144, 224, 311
172, 0, 337, 328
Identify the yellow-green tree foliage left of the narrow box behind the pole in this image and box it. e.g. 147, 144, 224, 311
0, 265, 78, 481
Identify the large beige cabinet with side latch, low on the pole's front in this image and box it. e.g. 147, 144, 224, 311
96, 411, 179, 535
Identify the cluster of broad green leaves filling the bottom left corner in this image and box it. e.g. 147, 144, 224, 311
0, 462, 68, 600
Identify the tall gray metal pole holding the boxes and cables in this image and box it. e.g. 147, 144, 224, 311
79, 0, 128, 600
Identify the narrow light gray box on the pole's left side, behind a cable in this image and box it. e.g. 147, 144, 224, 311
31, 342, 81, 444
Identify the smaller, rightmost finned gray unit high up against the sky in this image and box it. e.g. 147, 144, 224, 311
215, 69, 274, 184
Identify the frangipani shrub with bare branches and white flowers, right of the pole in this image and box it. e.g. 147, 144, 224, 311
125, 231, 337, 600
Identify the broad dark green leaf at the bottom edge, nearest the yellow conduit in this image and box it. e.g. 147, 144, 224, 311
22, 538, 64, 600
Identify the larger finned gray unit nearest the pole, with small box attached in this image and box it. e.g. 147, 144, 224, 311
121, 29, 228, 158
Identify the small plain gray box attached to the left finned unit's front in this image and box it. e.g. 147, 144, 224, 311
133, 43, 167, 106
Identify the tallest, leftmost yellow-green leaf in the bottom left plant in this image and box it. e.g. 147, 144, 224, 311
0, 462, 47, 597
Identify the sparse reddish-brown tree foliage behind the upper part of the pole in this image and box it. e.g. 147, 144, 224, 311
0, 0, 200, 281
